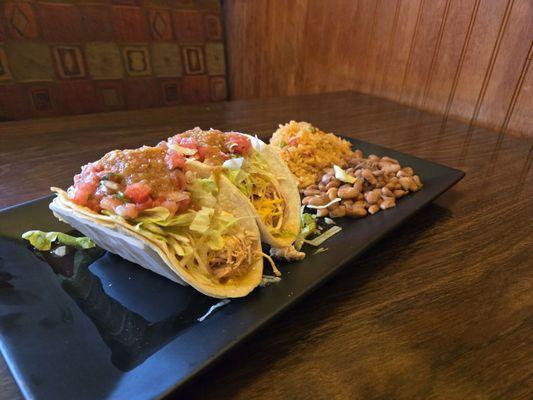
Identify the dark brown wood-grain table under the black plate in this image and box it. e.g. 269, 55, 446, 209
0, 92, 533, 399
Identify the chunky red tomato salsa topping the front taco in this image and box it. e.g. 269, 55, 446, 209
68, 146, 190, 219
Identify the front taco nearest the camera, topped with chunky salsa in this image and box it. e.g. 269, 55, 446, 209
50, 146, 263, 298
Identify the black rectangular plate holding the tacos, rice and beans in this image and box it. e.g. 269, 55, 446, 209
0, 140, 464, 400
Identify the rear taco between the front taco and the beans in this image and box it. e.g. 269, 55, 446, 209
158, 128, 300, 248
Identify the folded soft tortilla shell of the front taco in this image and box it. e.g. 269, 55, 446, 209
50, 162, 263, 298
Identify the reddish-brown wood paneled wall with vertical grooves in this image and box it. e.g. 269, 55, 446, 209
224, 0, 533, 137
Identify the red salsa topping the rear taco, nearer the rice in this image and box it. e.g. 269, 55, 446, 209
159, 128, 252, 166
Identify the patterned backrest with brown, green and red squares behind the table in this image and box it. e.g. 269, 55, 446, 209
0, 0, 227, 120
